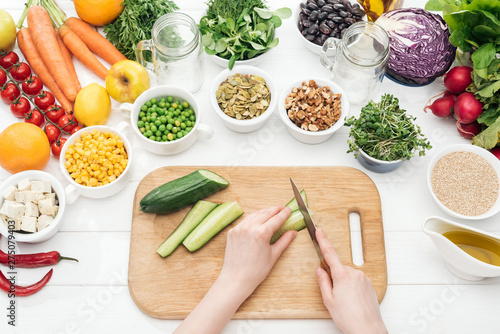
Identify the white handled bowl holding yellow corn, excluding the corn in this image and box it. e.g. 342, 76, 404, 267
59, 125, 133, 204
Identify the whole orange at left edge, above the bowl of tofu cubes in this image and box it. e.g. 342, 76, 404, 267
0, 122, 50, 174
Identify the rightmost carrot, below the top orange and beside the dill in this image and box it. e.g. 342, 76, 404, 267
64, 17, 127, 65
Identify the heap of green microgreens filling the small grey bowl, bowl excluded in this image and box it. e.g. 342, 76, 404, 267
345, 94, 432, 161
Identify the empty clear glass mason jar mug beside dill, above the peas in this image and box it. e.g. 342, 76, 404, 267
136, 12, 204, 93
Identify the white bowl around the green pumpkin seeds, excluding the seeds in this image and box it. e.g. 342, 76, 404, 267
210, 65, 278, 132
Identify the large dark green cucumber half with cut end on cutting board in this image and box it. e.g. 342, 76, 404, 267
139, 169, 229, 213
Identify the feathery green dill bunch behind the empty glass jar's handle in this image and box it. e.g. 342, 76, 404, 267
104, 0, 179, 60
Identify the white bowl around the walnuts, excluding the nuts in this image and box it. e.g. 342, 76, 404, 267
278, 78, 349, 144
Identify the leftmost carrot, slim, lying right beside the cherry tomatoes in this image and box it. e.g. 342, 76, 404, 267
17, 28, 73, 113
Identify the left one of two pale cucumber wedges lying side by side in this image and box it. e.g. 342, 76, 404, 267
156, 201, 217, 257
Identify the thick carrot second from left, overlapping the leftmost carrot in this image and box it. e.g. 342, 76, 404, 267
28, 6, 78, 101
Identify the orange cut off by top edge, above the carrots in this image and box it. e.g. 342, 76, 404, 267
73, 0, 123, 26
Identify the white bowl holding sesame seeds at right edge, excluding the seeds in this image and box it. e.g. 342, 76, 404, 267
427, 144, 500, 220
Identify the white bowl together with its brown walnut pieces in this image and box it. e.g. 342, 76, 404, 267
278, 78, 349, 144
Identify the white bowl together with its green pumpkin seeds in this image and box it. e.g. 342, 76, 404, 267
210, 65, 278, 132
